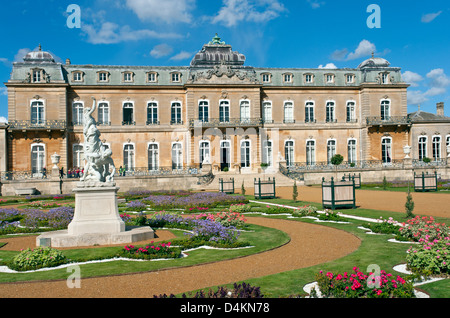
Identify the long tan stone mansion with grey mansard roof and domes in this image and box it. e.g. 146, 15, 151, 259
0, 35, 450, 179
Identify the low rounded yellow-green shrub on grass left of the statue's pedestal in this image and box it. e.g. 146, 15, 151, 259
9, 246, 69, 271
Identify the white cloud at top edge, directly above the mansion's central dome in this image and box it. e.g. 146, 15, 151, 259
212, 0, 286, 27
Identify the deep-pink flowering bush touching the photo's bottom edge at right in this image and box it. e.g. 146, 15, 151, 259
312, 266, 415, 298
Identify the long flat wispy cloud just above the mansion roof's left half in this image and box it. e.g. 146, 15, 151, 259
82, 22, 181, 44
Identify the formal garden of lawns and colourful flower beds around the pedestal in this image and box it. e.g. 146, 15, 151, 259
0, 190, 450, 298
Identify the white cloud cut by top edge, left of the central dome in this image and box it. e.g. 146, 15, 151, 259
126, 0, 195, 24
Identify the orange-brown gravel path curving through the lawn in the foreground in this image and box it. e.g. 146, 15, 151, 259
0, 217, 360, 298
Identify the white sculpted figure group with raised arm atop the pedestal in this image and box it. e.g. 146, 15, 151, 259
80, 98, 116, 182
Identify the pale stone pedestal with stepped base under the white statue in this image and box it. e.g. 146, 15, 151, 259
36, 182, 154, 247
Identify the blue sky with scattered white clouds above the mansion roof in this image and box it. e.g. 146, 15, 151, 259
0, 0, 450, 117
